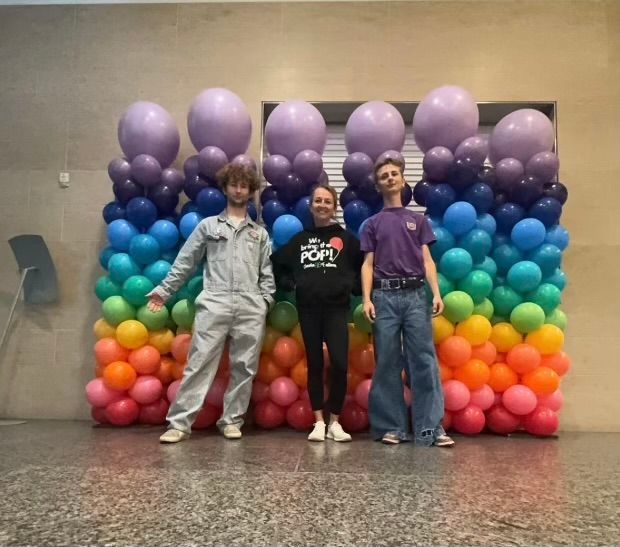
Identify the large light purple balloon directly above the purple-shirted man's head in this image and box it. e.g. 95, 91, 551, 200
344, 101, 405, 161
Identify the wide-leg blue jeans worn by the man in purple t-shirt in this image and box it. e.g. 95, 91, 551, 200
368, 287, 445, 446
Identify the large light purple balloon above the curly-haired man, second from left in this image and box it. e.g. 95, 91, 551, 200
187, 87, 252, 158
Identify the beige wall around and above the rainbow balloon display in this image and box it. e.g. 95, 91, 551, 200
0, 0, 620, 431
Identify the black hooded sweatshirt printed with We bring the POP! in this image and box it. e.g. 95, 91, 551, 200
271, 224, 364, 308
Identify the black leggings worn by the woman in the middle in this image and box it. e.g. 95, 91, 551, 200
299, 308, 349, 415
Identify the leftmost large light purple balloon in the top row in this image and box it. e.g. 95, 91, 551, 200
118, 101, 181, 167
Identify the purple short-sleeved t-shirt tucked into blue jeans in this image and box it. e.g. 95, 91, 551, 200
361, 207, 435, 279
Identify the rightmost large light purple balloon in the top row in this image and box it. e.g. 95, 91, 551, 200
489, 108, 555, 165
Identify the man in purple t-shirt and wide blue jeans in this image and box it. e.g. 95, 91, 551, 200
361, 159, 454, 446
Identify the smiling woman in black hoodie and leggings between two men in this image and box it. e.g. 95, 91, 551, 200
271, 186, 363, 442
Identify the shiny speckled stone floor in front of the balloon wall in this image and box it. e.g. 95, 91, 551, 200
0, 421, 620, 545
